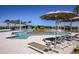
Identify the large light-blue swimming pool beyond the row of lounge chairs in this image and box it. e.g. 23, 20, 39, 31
12, 30, 68, 39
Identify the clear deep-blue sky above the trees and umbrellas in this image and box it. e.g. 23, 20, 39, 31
0, 5, 75, 26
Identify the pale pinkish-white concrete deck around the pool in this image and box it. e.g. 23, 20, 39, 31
0, 32, 79, 54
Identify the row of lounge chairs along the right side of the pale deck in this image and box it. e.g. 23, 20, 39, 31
28, 34, 79, 53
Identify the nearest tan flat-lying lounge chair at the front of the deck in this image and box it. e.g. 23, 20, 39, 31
28, 42, 57, 54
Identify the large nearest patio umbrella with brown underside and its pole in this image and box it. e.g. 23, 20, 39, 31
41, 11, 76, 44
